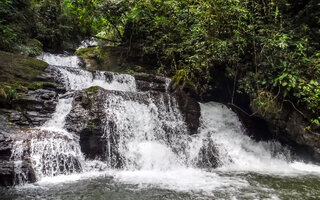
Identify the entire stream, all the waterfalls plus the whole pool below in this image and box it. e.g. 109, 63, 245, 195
0, 48, 320, 199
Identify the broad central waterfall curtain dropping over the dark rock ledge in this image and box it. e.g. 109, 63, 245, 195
103, 93, 187, 169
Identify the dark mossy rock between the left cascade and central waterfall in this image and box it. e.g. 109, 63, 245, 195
65, 89, 106, 159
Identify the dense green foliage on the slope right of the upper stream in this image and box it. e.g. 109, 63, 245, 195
99, 0, 320, 130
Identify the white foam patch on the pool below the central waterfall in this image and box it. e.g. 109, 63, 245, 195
114, 168, 249, 195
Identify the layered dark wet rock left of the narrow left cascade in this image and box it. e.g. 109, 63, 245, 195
2, 66, 66, 128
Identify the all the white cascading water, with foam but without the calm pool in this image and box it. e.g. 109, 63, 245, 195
5, 45, 320, 199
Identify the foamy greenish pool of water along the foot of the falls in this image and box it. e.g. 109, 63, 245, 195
0, 170, 320, 200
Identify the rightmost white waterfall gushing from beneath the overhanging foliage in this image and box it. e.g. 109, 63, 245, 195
200, 102, 320, 175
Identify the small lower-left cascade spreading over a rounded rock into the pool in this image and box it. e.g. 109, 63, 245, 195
30, 131, 84, 180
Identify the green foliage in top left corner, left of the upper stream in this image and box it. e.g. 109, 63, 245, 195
0, 0, 99, 52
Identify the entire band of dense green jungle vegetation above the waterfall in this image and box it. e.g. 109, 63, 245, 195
0, 0, 320, 131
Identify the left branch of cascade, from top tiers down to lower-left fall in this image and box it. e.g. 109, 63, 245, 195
11, 53, 136, 184
